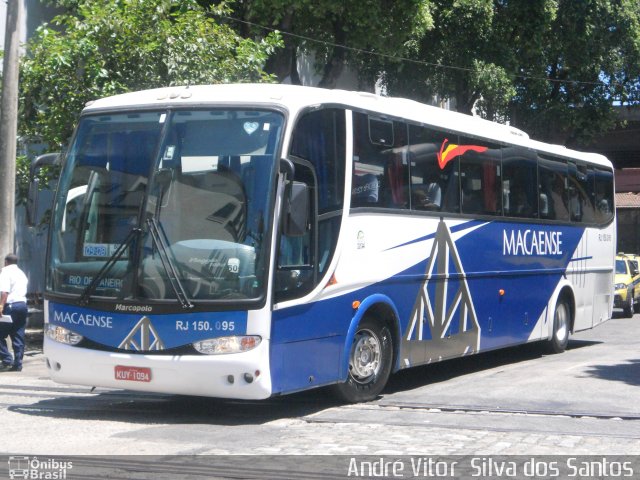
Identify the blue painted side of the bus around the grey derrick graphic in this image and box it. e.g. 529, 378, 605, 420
271, 222, 584, 393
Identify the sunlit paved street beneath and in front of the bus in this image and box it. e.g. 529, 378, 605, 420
0, 315, 640, 455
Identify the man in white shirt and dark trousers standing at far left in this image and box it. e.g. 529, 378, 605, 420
0, 253, 28, 372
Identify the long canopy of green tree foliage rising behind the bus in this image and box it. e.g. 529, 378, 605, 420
21, 0, 640, 145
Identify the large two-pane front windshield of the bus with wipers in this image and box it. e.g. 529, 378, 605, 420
47, 109, 283, 306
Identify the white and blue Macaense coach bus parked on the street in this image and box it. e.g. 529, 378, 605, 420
44, 84, 616, 401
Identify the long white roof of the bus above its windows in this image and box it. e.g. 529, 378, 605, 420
84, 83, 611, 167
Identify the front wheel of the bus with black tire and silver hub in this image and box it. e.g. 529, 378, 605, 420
334, 318, 393, 403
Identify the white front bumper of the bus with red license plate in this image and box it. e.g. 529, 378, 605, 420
44, 336, 271, 400
